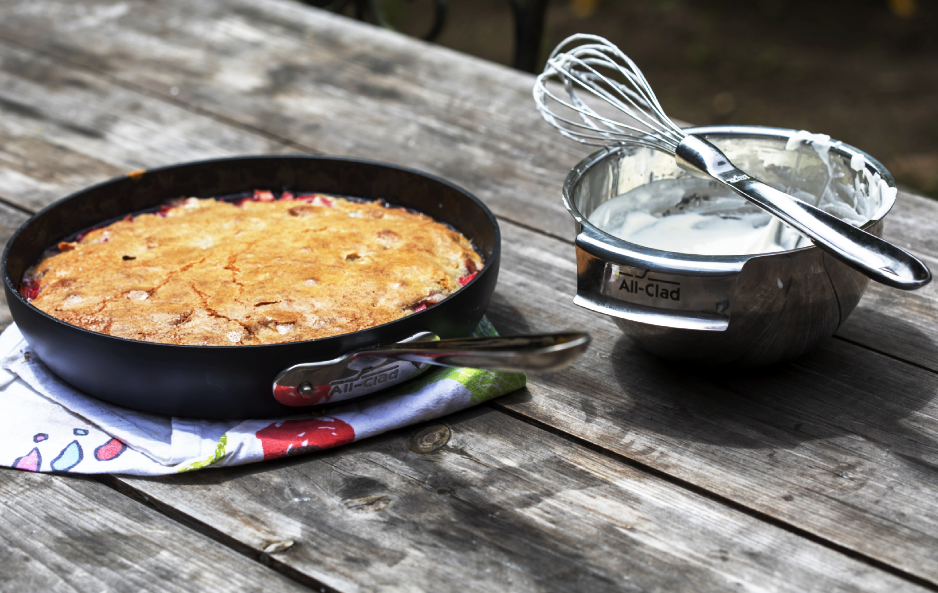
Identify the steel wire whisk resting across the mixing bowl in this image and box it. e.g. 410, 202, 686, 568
534, 34, 931, 290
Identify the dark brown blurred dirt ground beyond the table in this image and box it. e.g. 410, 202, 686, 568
324, 0, 938, 198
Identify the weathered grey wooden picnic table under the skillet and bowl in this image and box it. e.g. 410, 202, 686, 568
0, 0, 938, 592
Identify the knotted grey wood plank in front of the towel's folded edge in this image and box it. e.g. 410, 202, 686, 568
108, 409, 917, 592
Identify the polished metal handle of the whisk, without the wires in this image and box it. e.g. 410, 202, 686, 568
675, 136, 931, 290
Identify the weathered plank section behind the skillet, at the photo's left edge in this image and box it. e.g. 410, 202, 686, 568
0, 43, 295, 210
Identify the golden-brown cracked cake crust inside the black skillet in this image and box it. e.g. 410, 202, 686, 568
24, 192, 482, 346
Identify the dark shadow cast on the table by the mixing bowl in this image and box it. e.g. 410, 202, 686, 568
613, 319, 938, 450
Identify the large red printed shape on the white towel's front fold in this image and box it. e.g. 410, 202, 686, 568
255, 416, 355, 459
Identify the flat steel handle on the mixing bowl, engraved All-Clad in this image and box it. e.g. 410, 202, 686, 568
573, 225, 745, 331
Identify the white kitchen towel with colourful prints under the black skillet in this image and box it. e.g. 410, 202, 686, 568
0, 319, 525, 476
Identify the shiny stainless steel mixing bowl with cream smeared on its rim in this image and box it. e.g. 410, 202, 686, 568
563, 126, 895, 366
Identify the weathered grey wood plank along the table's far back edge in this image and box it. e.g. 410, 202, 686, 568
0, 0, 576, 236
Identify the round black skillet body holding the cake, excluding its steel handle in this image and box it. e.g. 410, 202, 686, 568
3, 155, 501, 418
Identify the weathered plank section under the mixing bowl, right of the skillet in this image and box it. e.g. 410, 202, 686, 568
489, 225, 938, 582
